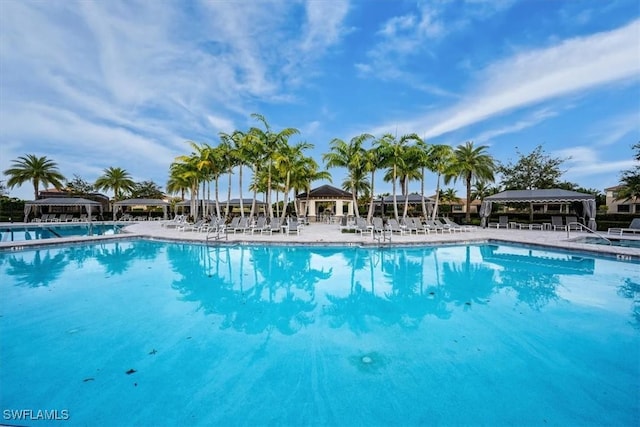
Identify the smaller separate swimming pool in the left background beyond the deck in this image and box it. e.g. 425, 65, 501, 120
0, 223, 121, 242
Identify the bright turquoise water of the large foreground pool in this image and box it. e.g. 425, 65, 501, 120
0, 240, 640, 426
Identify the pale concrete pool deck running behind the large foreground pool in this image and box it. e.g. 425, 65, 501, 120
0, 221, 640, 261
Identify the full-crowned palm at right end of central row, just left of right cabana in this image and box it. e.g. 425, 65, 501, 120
445, 141, 496, 223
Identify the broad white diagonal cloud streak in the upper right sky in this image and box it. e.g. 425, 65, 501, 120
375, 21, 640, 137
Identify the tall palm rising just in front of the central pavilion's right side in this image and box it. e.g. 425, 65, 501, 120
322, 133, 373, 218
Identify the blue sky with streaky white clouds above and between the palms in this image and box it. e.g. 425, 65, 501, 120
0, 0, 640, 199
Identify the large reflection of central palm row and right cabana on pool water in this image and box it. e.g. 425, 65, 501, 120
168, 244, 595, 334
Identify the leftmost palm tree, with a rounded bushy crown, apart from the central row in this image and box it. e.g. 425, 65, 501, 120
4, 154, 65, 200
